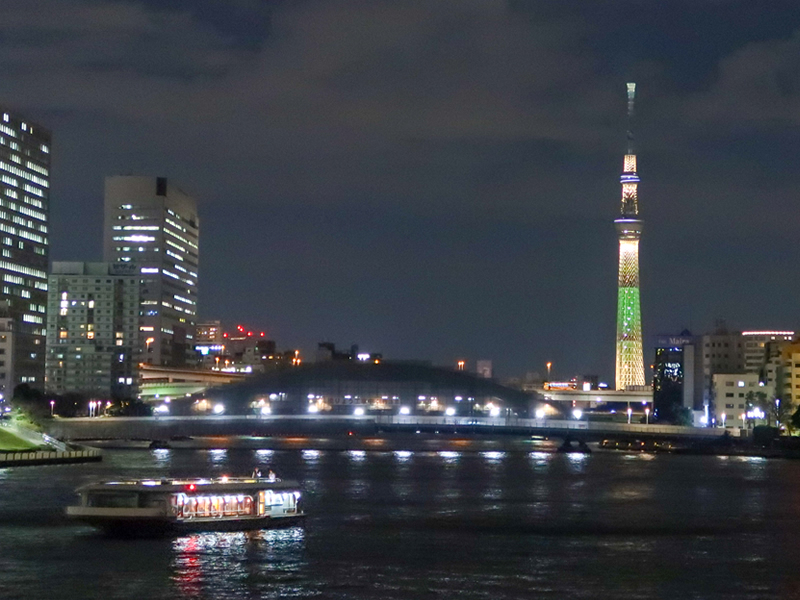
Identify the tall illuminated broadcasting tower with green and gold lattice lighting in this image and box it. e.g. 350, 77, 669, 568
614, 83, 645, 390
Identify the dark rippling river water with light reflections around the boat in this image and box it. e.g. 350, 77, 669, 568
0, 442, 800, 600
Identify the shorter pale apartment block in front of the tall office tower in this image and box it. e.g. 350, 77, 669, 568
46, 262, 140, 399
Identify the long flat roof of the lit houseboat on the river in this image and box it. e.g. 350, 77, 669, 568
77, 477, 299, 494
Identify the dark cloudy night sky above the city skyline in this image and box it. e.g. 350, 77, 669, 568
0, 0, 800, 381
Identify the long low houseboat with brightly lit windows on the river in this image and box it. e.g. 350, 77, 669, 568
67, 477, 305, 535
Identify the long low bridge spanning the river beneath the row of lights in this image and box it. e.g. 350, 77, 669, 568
46, 414, 741, 442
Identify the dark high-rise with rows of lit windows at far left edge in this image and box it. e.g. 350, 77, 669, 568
0, 107, 50, 395
